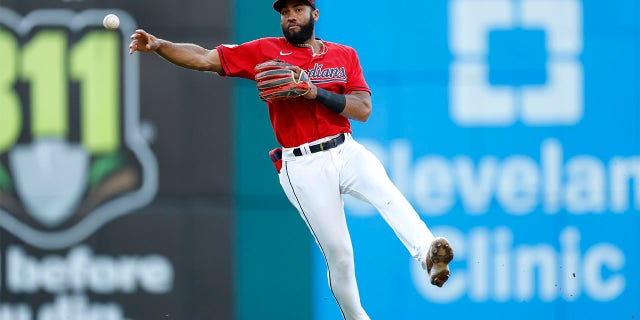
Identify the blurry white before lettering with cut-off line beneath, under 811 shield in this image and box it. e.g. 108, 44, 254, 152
0, 245, 175, 320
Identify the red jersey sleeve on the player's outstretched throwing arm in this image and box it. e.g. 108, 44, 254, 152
216, 39, 260, 80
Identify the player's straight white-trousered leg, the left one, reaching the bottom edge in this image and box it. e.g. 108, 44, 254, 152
280, 152, 369, 320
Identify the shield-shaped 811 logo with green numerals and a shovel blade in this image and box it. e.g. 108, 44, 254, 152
0, 7, 158, 249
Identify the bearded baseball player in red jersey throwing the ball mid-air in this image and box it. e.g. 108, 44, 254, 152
129, 0, 453, 320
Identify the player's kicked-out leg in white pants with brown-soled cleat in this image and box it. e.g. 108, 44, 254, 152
340, 139, 453, 286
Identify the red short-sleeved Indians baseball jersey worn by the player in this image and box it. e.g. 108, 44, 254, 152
216, 38, 371, 148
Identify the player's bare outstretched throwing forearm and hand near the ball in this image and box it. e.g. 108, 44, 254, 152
129, 29, 223, 74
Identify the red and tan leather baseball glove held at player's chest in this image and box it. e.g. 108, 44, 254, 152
255, 60, 311, 102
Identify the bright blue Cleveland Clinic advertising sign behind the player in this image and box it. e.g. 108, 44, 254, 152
314, 0, 640, 320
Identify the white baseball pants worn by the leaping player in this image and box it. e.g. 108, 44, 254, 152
279, 134, 434, 320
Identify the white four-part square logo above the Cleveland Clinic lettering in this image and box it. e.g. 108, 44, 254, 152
449, 0, 584, 127
